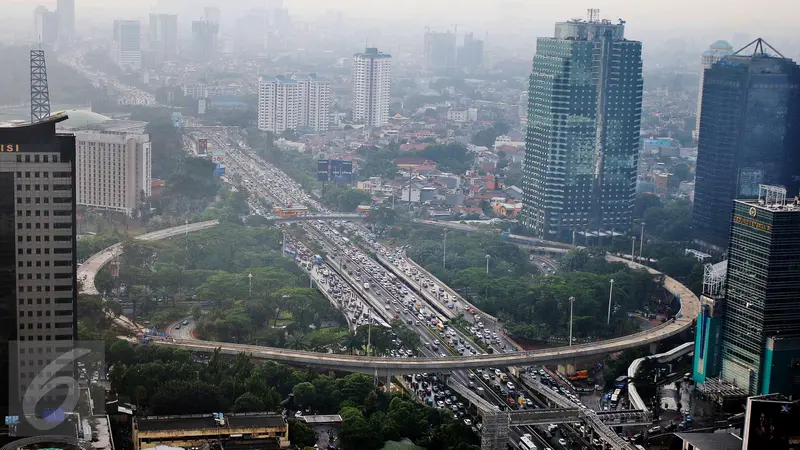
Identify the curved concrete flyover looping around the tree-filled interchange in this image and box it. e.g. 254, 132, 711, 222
79, 221, 700, 376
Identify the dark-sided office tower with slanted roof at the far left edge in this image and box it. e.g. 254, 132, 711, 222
0, 114, 78, 422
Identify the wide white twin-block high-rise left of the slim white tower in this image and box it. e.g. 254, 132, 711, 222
258, 73, 331, 133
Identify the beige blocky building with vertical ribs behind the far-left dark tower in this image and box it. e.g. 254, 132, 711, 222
59, 110, 152, 215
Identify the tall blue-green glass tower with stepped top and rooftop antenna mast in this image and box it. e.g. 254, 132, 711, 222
522, 10, 642, 240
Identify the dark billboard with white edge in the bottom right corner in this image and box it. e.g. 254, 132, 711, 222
742, 397, 800, 450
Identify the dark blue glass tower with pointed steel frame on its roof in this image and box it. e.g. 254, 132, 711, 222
692, 39, 800, 252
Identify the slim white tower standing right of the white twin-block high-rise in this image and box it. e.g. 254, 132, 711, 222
352, 48, 392, 127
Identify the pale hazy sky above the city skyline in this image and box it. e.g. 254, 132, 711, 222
0, 0, 800, 29
